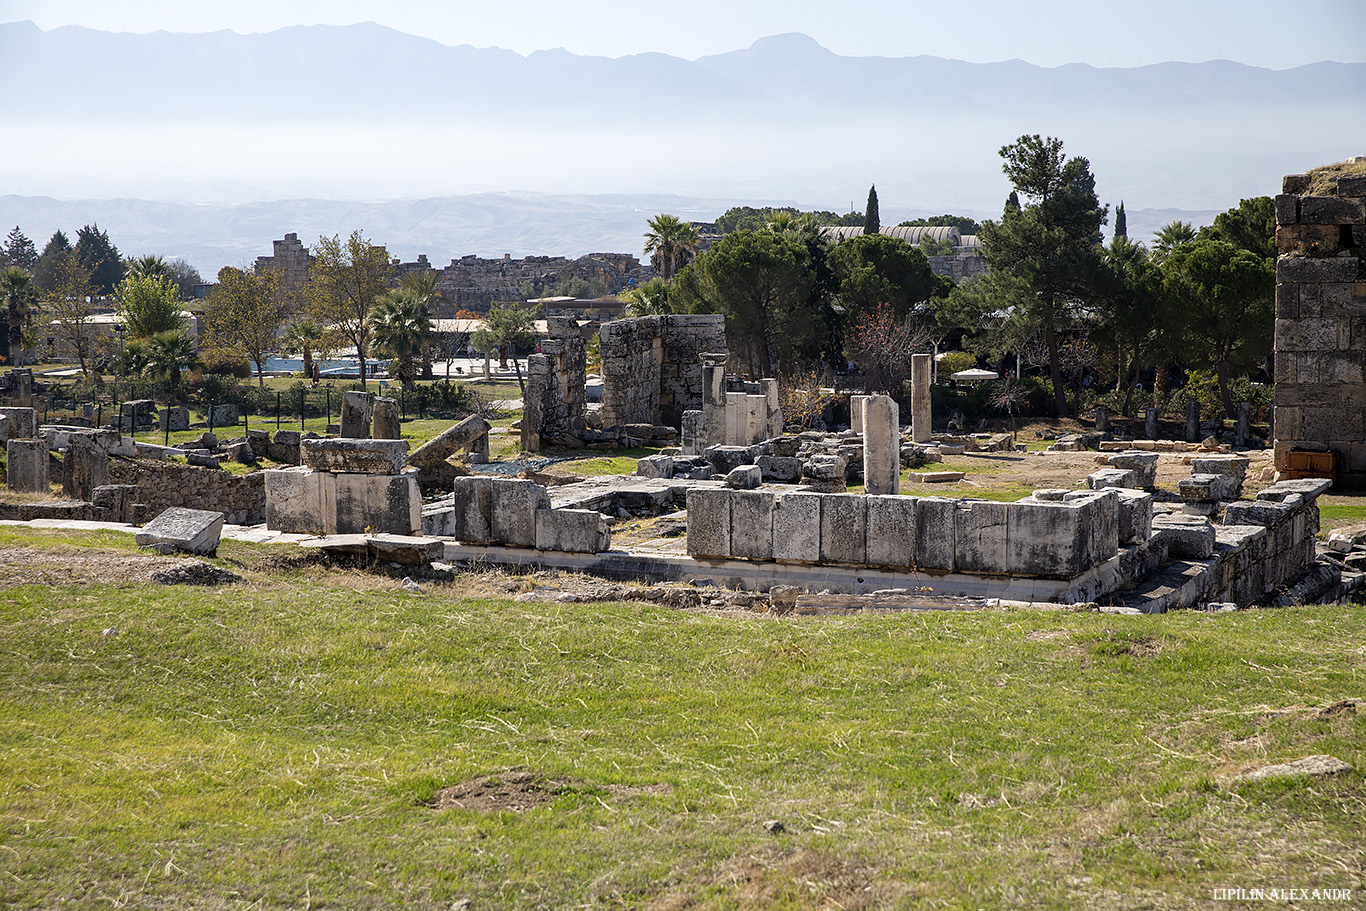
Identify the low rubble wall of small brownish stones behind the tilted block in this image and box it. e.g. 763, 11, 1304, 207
109, 459, 265, 524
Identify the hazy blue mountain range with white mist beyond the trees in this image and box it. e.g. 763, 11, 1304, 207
0, 22, 1366, 268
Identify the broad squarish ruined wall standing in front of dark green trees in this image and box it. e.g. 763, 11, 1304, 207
600, 314, 727, 428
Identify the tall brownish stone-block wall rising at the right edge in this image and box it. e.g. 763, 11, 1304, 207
1274, 167, 1366, 486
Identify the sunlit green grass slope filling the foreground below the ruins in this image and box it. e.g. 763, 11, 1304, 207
0, 529, 1366, 910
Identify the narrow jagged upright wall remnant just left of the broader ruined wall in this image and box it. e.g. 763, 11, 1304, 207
522, 317, 587, 452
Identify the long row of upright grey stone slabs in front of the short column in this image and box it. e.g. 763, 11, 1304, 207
687, 489, 1125, 579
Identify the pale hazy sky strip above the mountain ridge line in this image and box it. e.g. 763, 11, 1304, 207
0, 0, 1366, 70
